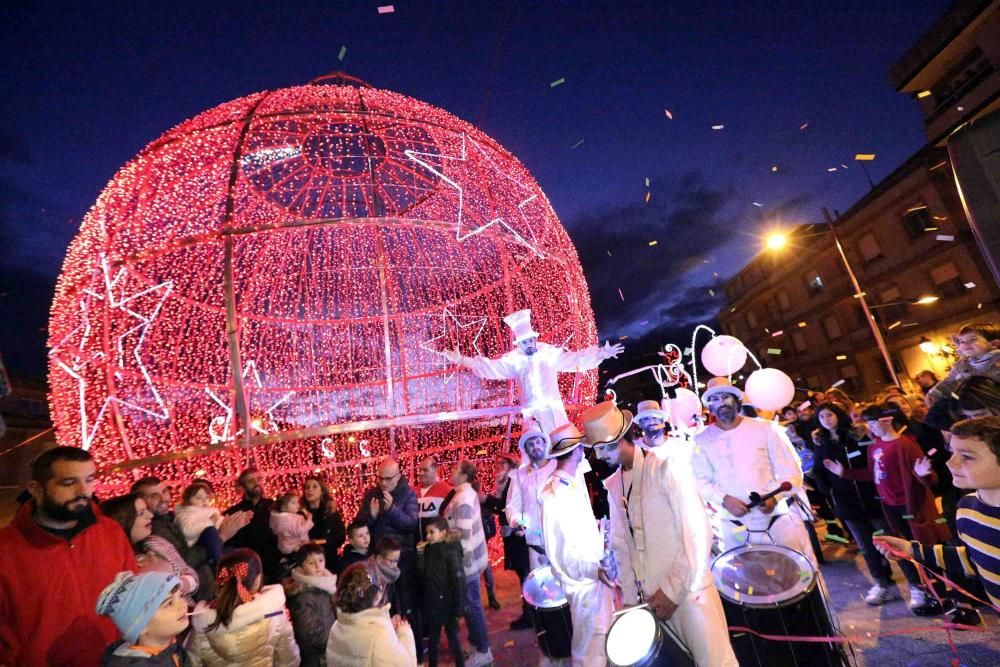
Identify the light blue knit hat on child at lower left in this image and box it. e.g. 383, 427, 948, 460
97, 572, 181, 644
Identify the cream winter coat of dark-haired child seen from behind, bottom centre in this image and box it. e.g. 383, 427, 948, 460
326, 605, 417, 667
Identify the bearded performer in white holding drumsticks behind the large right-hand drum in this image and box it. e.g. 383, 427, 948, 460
691, 378, 819, 572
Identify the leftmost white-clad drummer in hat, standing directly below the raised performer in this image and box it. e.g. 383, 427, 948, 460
504, 422, 556, 570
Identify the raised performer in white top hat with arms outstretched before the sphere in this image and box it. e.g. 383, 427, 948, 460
443, 309, 625, 433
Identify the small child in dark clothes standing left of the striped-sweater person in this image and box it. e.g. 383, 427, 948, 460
417, 517, 465, 667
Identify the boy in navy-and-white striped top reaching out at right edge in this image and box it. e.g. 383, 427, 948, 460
874, 417, 1000, 607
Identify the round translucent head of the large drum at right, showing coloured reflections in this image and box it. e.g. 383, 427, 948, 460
712, 544, 816, 607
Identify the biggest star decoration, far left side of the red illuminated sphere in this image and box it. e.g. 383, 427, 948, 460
49, 255, 173, 450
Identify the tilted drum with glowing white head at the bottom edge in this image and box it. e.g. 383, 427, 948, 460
604, 606, 694, 667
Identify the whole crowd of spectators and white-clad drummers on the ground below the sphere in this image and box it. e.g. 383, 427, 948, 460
0, 325, 1000, 667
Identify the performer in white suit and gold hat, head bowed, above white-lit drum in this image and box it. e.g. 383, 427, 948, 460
581, 402, 737, 667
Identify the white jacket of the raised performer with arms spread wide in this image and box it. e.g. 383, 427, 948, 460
461, 342, 607, 433
